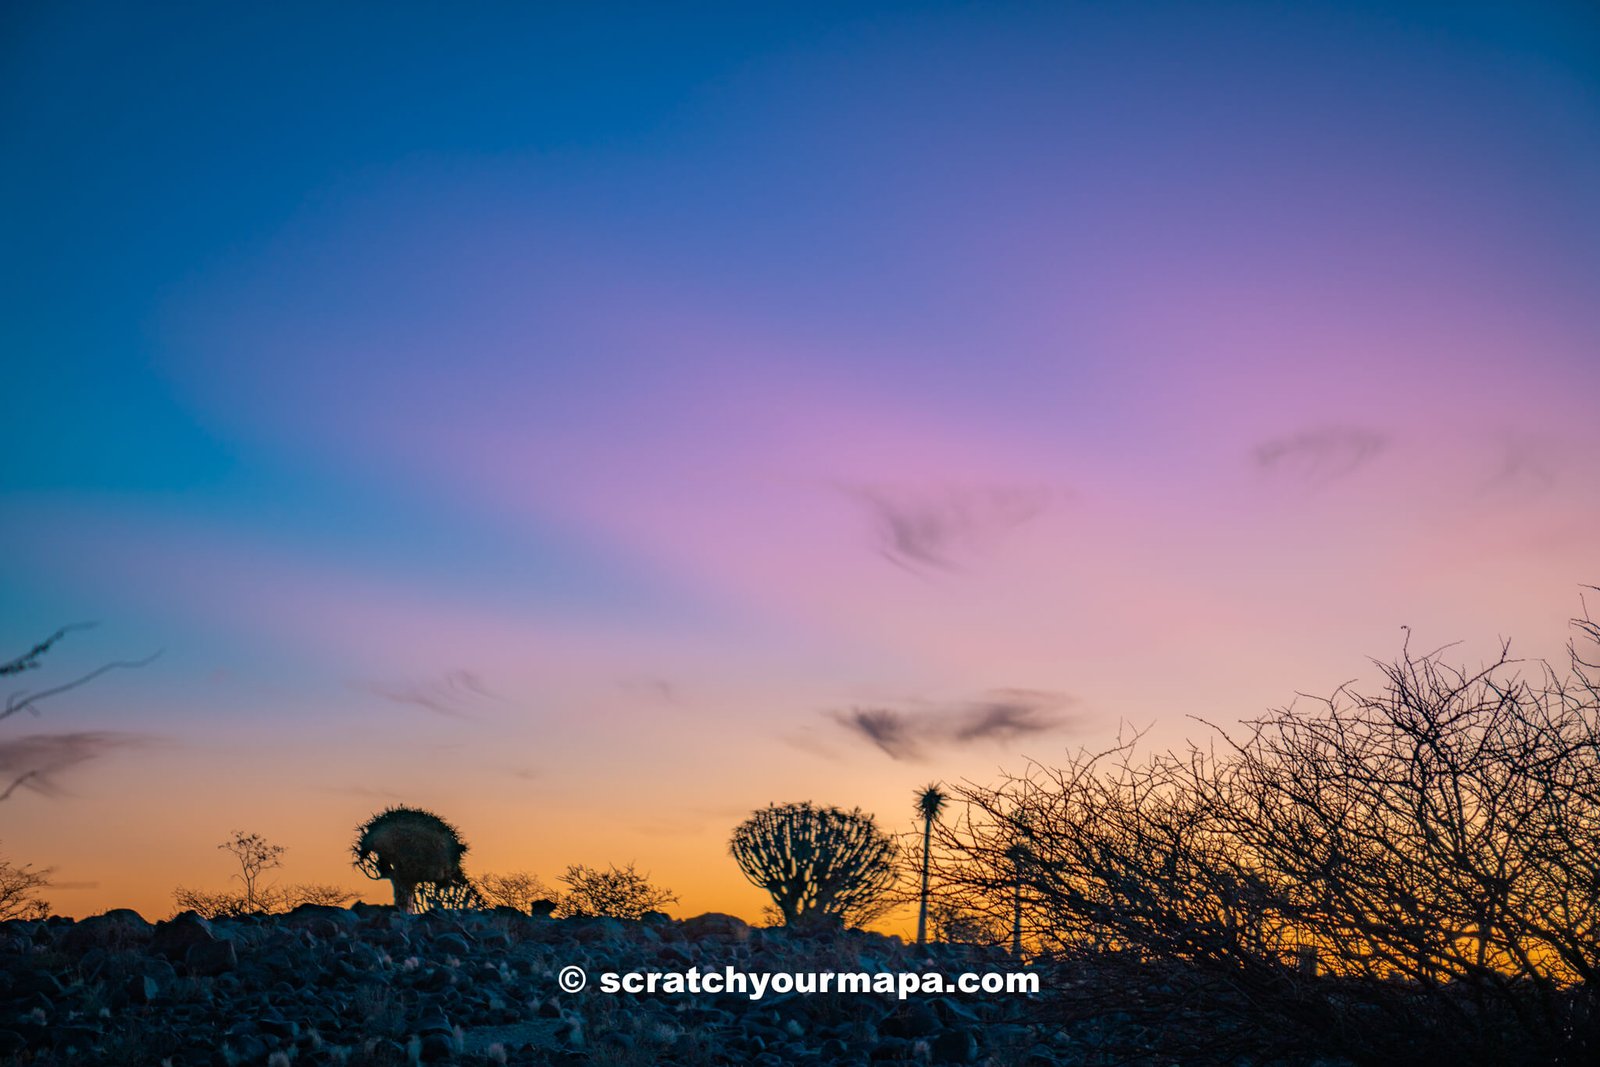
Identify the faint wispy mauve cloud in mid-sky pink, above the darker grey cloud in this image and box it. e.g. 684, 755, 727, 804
840, 485, 1062, 569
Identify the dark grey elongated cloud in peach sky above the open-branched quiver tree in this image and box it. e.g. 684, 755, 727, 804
829, 689, 1075, 760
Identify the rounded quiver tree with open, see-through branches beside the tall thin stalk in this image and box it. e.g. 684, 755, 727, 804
730, 801, 898, 926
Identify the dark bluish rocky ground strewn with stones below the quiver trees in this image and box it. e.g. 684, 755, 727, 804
0, 905, 1072, 1067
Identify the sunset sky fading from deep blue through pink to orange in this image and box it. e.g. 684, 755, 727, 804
0, 2, 1600, 918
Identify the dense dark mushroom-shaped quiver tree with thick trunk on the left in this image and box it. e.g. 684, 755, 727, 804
360, 806, 482, 912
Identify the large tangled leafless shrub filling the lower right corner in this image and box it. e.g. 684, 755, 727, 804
934, 624, 1600, 1064
